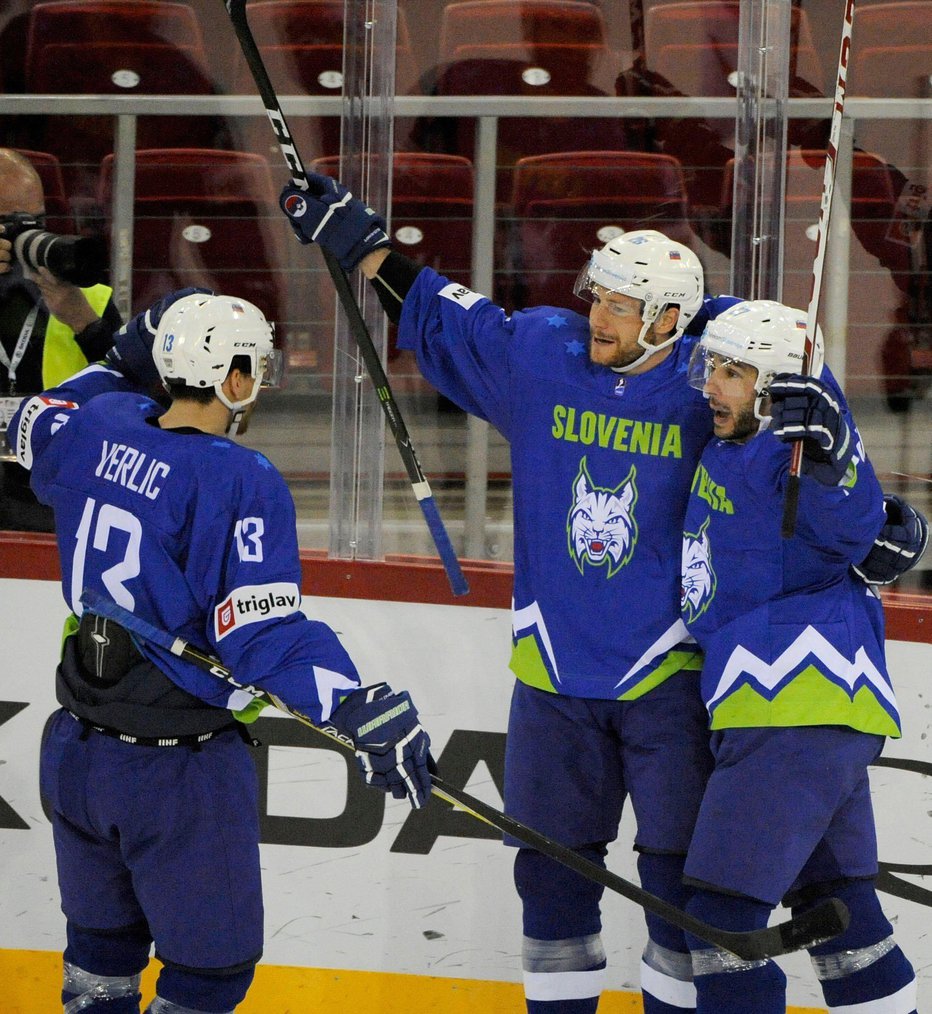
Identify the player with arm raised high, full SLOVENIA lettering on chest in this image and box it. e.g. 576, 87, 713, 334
281, 174, 924, 1014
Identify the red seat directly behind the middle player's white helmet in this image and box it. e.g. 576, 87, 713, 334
512, 151, 693, 306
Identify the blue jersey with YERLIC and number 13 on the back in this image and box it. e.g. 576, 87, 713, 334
10, 365, 359, 723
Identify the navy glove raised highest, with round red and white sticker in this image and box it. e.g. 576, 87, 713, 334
279, 172, 390, 271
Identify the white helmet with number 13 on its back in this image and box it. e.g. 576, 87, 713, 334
152, 293, 283, 413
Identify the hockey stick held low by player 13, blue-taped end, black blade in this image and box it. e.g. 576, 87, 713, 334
81, 589, 849, 961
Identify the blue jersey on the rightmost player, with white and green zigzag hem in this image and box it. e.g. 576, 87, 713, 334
682, 369, 900, 736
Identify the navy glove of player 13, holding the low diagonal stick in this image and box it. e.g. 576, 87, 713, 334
331, 683, 430, 810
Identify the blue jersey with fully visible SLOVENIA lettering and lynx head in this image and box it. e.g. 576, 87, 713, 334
399, 269, 735, 700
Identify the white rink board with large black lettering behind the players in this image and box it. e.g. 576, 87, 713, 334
0, 579, 932, 1010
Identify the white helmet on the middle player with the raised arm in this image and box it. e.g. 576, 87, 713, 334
573, 229, 705, 372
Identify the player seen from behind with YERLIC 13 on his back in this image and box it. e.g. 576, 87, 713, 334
12, 292, 430, 1014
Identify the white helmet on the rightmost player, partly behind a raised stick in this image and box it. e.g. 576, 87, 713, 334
688, 299, 826, 430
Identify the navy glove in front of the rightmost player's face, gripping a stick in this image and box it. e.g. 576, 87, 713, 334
768, 373, 854, 486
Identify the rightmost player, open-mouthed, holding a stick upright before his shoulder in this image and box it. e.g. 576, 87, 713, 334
683, 300, 927, 1014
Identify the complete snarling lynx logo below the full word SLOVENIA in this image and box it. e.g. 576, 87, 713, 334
567, 457, 638, 577
